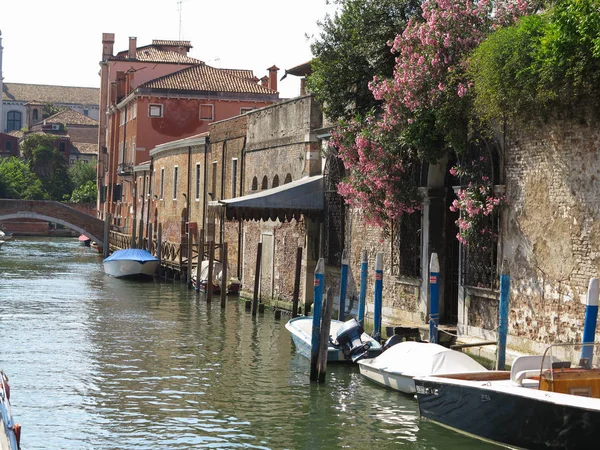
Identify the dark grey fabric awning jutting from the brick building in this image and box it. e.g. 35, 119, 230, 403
209, 175, 323, 222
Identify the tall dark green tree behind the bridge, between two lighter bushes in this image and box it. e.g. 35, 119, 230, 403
21, 134, 72, 201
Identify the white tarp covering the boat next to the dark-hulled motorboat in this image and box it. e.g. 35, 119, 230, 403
371, 341, 487, 377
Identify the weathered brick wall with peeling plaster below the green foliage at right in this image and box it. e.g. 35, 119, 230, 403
502, 110, 600, 345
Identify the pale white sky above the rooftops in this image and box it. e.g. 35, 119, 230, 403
0, 0, 334, 98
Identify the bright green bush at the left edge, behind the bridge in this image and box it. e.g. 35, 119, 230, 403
0, 157, 49, 200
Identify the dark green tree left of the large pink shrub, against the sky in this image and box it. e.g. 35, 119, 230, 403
307, 0, 422, 120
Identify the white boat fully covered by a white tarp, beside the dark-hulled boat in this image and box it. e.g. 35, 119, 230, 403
358, 341, 486, 394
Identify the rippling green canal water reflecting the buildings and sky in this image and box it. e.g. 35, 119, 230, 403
0, 237, 495, 450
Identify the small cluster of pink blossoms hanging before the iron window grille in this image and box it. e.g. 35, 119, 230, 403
450, 156, 505, 246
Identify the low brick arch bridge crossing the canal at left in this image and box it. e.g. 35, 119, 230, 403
0, 199, 104, 246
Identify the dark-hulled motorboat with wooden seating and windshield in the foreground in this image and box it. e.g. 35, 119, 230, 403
415, 344, 600, 450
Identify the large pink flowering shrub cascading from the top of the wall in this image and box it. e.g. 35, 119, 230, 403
332, 0, 533, 232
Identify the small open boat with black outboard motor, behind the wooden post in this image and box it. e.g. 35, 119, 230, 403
285, 316, 381, 362
